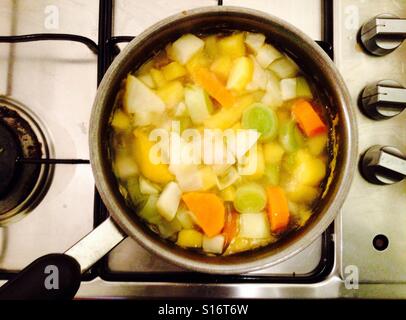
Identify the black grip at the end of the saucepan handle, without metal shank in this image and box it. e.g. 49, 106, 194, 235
0, 253, 81, 300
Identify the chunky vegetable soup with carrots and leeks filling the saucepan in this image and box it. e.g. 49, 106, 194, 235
109, 31, 330, 255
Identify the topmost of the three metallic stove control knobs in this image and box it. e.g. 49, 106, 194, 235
360, 14, 406, 56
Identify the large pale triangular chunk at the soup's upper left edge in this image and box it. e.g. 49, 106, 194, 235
123, 75, 165, 113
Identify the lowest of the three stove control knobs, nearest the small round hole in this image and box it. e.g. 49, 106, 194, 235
360, 145, 406, 185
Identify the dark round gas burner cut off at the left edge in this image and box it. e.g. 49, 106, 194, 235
0, 96, 53, 226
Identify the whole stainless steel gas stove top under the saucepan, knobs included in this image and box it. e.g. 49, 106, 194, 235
0, 0, 406, 298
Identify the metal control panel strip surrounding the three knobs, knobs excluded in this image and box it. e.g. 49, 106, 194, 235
336, 0, 406, 283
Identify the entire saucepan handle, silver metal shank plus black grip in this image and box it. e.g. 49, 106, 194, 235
0, 218, 126, 300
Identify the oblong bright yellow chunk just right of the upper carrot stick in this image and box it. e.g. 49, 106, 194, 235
227, 57, 254, 91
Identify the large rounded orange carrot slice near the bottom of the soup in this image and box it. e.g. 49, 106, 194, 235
182, 192, 225, 237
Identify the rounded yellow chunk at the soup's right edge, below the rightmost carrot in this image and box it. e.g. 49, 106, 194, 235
294, 150, 326, 186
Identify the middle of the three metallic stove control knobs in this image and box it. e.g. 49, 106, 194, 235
360, 80, 406, 120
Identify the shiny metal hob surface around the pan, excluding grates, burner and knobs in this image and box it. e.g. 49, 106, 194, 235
0, 0, 406, 298
